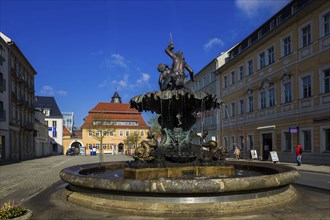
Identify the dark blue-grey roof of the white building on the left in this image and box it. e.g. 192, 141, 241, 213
34, 96, 63, 118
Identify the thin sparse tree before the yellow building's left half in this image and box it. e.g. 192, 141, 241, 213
84, 114, 116, 162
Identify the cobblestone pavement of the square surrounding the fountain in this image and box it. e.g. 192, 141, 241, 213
0, 155, 330, 220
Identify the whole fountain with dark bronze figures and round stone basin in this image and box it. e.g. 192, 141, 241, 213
60, 40, 299, 217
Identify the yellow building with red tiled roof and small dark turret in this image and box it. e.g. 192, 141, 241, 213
82, 92, 149, 155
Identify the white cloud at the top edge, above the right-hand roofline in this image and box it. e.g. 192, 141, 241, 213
235, 0, 290, 17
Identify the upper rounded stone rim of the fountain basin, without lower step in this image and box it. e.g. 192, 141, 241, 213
60, 161, 299, 196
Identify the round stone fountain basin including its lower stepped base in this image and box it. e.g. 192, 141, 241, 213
60, 161, 299, 217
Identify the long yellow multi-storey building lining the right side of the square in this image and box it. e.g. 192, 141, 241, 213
217, 0, 330, 165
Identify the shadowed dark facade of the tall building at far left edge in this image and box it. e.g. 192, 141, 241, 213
0, 33, 36, 160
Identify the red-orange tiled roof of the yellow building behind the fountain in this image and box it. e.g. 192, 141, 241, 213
82, 102, 149, 129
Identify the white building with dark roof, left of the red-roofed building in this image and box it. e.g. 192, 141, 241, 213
35, 96, 64, 154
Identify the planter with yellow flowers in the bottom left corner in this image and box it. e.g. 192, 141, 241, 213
0, 201, 32, 220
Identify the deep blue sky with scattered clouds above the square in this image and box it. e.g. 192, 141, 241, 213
0, 0, 290, 126
